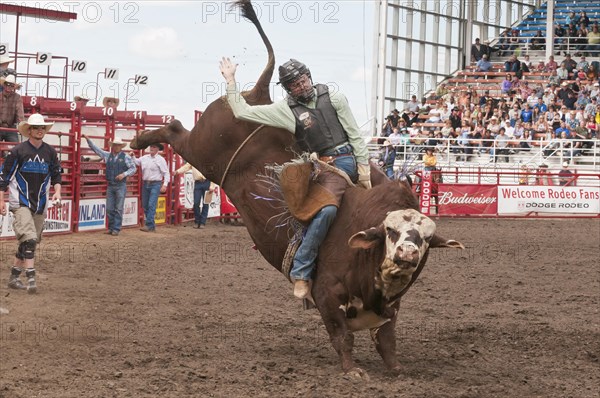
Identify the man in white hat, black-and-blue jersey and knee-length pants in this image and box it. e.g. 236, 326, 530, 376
0, 113, 62, 293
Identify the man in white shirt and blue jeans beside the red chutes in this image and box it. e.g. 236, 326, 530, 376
132, 143, 171, 232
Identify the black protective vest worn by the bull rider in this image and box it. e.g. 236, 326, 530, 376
288, 84, 348, 153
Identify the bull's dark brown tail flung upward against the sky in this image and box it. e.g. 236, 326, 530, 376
233, 0, 275, 103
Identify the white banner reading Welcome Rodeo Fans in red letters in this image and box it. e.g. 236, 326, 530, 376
498, 185, 600, 214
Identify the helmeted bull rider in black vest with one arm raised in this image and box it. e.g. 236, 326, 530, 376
220, 58, 371, 298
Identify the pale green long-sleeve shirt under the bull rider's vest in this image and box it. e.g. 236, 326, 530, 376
227, 82, 369, 164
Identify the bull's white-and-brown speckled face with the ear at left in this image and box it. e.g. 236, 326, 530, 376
349, 209, 435, 298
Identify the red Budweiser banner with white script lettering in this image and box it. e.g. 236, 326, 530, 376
438, 184, 498, 215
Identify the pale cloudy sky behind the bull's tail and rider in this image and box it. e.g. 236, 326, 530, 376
0, 0, 374, 128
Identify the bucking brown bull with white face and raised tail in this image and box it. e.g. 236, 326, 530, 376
131, 0, 461, 375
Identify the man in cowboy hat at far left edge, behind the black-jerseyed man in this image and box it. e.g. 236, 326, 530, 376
0, 75, 25, 142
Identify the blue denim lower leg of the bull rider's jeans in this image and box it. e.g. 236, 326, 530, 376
290, 206, 337, 281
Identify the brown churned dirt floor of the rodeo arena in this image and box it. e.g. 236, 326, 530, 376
0, 219, 600, 398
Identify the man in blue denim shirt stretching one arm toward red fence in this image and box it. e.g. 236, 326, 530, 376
82, 134, 136, 236
